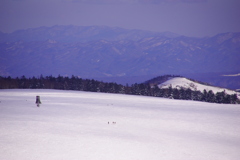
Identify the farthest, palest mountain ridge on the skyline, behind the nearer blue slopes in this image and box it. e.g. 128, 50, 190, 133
0, 25, 179, 43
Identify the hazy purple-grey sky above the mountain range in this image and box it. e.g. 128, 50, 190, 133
0, 0, 240, 37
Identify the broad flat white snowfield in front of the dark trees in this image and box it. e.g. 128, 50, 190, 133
0, 89, 240, 160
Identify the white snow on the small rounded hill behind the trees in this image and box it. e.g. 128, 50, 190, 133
158, 77, 240, 98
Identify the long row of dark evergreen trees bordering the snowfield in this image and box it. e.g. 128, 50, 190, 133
0, 75, 240, 104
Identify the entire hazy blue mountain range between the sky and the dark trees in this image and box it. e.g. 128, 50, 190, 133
0, 26, 240, 89
